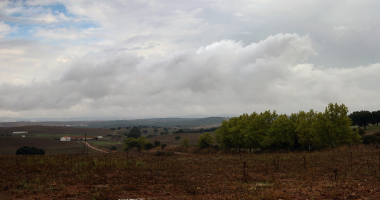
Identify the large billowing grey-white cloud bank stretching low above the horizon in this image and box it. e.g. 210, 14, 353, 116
0, 34, 380, 117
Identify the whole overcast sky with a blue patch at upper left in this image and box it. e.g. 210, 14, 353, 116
0, 0, 380, 118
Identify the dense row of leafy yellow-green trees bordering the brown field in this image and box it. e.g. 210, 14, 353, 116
214, 103, 360, 151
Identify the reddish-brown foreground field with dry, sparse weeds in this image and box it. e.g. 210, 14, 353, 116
0, 146, 380, 199
